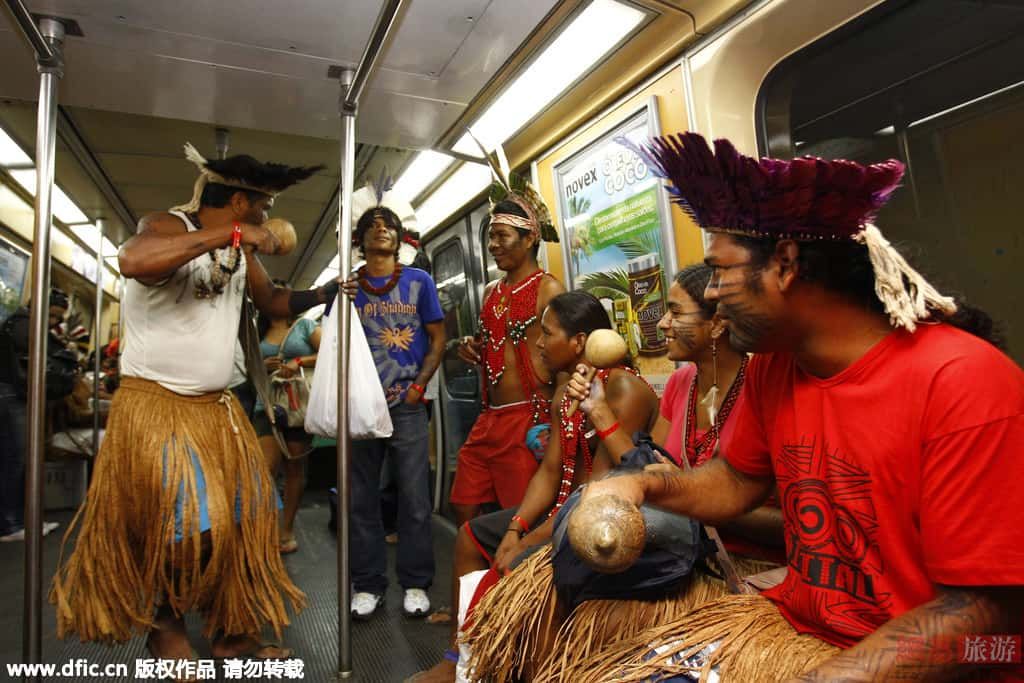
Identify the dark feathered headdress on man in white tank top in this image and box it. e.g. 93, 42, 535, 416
171, 142, 324, 213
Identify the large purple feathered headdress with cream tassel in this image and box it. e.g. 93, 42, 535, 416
616, 133, 956, 332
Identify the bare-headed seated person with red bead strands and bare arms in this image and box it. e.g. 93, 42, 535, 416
415, 292, 657, 683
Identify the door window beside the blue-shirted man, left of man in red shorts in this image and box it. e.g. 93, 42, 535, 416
433, 240, 478, 398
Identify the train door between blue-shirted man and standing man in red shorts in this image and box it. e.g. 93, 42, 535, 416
427, 217, 480, 513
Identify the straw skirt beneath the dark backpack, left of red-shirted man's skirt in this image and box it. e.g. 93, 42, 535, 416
462, 546, 777, 683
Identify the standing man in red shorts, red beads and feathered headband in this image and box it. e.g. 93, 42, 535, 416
452, 176, 565, 526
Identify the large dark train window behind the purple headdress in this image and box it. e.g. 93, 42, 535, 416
757, 0, 1024, 361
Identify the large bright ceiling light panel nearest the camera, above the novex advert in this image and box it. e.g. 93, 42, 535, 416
453, 0, 646, 157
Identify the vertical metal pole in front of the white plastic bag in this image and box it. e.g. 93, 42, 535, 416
337, 69, 355, 679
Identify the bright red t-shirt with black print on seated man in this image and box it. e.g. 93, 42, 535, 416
723, 325, 1024, 647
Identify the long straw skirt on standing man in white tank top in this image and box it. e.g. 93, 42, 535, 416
50, 378, 305, 642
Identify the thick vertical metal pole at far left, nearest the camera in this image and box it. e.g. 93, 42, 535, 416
22, 18, 63, 680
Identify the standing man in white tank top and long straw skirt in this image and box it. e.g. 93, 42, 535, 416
50, 145, 338, 673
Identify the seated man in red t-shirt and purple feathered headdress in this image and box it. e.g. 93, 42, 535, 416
565, 133, 1024, 681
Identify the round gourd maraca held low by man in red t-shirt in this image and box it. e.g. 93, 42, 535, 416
568, 495, 647, 573
